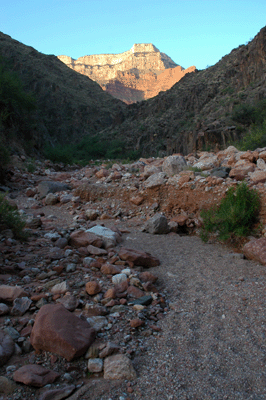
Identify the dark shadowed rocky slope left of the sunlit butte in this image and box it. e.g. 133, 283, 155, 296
0, 33, 125, 150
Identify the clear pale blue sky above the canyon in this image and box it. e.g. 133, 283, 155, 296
0, 0, 266, 69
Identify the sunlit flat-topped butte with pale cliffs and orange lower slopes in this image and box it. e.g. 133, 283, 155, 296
58, 43, 196, 104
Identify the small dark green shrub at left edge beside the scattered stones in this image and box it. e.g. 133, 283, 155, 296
0, 193, 27, 240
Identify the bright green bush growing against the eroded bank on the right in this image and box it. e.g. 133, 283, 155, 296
201, 182, 260, 241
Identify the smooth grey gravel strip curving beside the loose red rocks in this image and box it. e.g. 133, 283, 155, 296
98, 229, 266, 400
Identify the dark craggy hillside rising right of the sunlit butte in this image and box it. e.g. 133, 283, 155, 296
99, 27, 266, 155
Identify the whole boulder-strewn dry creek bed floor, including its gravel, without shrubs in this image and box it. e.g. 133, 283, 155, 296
0, 146, 266, 400
